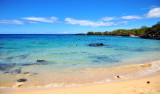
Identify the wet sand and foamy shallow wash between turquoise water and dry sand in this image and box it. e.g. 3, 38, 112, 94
0, 60, 160, 88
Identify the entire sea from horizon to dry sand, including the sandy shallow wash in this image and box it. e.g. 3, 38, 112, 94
0, 34, 160, 88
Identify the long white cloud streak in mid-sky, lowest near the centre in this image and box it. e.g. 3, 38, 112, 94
65, 18, 117, 27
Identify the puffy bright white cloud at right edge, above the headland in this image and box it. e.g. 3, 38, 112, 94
145, 7, 160, 18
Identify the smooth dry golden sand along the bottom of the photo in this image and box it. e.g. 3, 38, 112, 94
0, 72, 160, 94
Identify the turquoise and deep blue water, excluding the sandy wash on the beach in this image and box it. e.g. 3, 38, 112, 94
0, 35, 160, 86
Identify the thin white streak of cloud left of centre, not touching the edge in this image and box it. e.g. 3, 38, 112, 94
22, 17, 58, 23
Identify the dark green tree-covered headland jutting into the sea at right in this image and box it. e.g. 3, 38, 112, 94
86, 22, 160, 39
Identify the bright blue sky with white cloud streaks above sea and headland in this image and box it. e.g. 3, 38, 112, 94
0, 0, 160, 34
